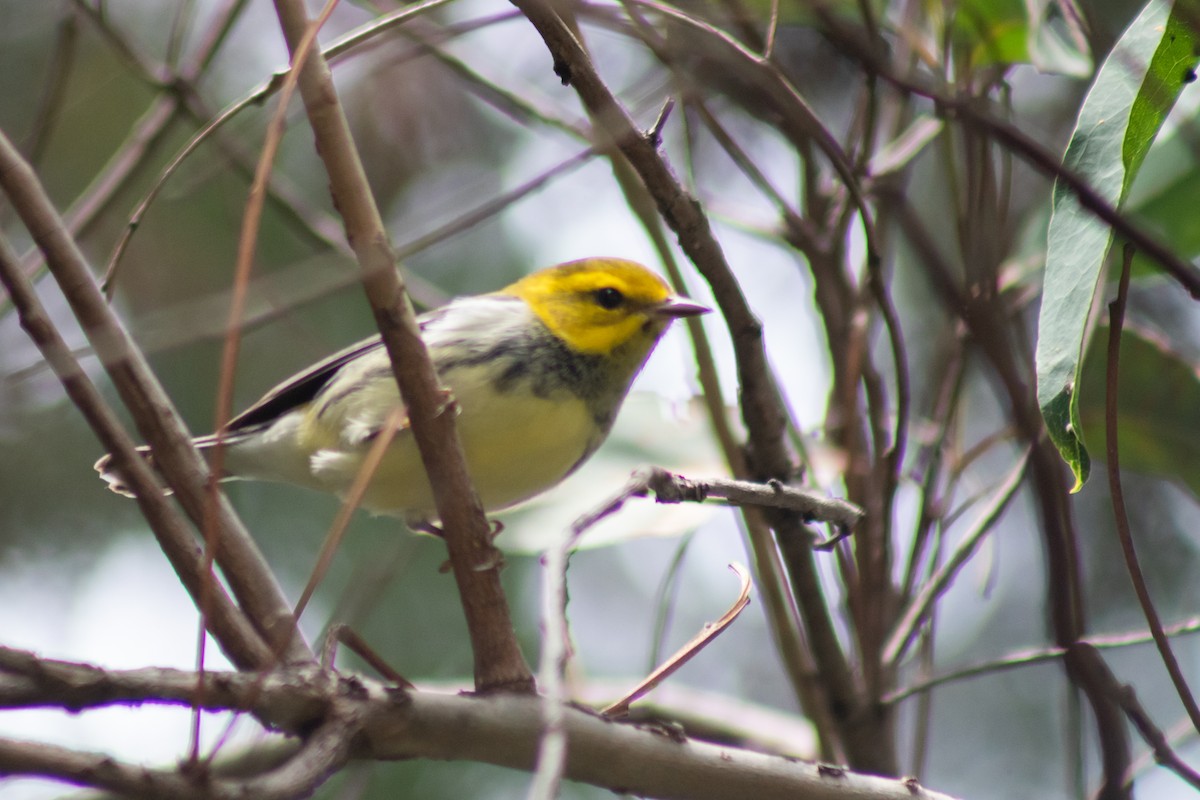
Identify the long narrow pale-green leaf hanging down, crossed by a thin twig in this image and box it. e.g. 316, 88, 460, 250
1037, 0, 1198, 491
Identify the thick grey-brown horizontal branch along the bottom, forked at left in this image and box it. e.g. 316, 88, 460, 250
0, 650, 950, 800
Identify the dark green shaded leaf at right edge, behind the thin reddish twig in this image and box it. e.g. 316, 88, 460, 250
1079, 327, 1200, 498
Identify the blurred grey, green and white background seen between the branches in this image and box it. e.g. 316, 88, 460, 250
0, 0, 1200, 799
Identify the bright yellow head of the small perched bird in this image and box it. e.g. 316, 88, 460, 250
500, 258, 709, 355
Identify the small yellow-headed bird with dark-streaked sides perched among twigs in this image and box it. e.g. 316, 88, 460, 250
96, 258, 709, 528
